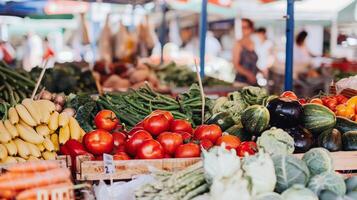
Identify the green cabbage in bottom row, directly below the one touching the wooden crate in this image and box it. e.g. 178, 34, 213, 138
308, 172, 347, 196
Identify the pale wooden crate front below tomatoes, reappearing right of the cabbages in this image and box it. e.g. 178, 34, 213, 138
76, 151, 357, 181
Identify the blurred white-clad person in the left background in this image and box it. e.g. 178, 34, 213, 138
22, 32, 43, 71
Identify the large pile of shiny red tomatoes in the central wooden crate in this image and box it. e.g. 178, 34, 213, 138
61, 110, 257, 160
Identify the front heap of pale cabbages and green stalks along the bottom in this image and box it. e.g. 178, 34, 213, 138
135, 145, 357, 200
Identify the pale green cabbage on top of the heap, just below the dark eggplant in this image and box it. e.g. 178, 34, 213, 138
257, 127, 295, 155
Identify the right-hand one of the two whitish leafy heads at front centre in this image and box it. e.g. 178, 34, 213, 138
242, 152, 276, 194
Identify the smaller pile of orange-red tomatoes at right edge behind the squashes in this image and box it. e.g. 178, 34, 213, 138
280, 91, 357, 122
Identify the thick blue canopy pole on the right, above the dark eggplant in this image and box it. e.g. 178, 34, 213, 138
285, 0, 294, 91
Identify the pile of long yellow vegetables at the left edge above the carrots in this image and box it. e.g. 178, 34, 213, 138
0, 98, 85, 163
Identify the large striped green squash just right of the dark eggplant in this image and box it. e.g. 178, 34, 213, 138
302, 103, 336, 135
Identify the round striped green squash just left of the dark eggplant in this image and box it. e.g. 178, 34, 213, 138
241, 105, 270, 135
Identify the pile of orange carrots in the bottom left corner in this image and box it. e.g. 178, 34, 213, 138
0, 161, 73, 200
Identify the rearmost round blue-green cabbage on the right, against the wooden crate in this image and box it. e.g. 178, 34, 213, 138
302, 148, 333, 176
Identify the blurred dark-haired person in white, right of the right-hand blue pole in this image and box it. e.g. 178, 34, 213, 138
294, 31, 312, 76
